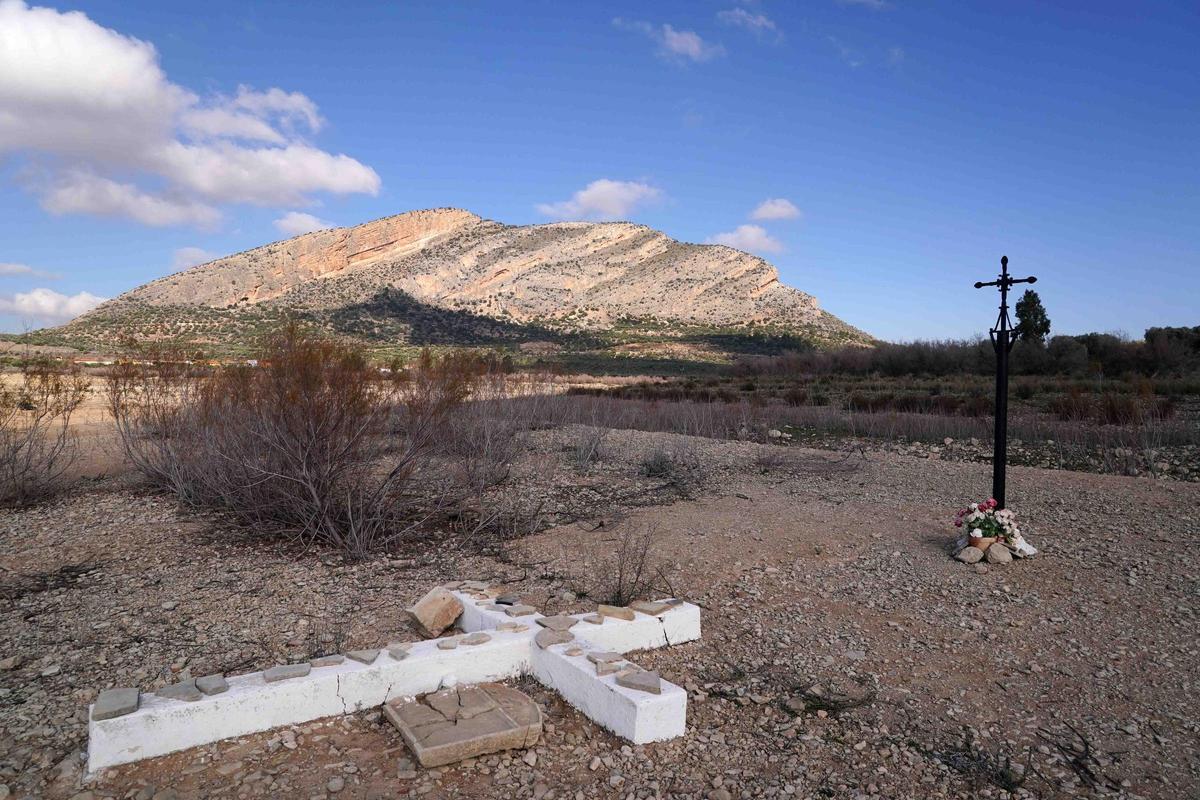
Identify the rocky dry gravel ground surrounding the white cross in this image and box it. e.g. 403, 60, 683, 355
0, 428, 1200, 800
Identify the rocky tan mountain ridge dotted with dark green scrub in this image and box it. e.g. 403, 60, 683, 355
34, 209, 870, 362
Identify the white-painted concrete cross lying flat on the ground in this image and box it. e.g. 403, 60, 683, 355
88, 591, 700, 772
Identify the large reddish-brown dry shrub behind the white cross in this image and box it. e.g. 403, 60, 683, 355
108, 326, 472, 557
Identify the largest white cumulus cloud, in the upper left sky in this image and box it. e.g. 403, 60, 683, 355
0, 0, 380, 227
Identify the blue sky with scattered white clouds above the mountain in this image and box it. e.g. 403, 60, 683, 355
0, 0, 1200, 341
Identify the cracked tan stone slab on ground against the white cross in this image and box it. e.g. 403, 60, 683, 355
384, 684, 541, 768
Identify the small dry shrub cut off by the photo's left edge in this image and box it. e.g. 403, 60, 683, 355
0, 362, 89, 505
